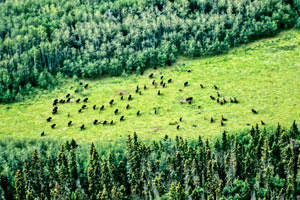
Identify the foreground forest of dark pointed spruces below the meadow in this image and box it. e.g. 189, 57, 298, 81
0, 122, 300, 200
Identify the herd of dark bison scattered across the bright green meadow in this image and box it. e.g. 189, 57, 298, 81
41, 70, 265, 136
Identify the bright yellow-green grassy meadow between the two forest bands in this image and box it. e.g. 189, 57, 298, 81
0, 30, 300, 142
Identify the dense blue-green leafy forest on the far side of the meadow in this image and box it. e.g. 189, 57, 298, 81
0, 0, 299, 103
